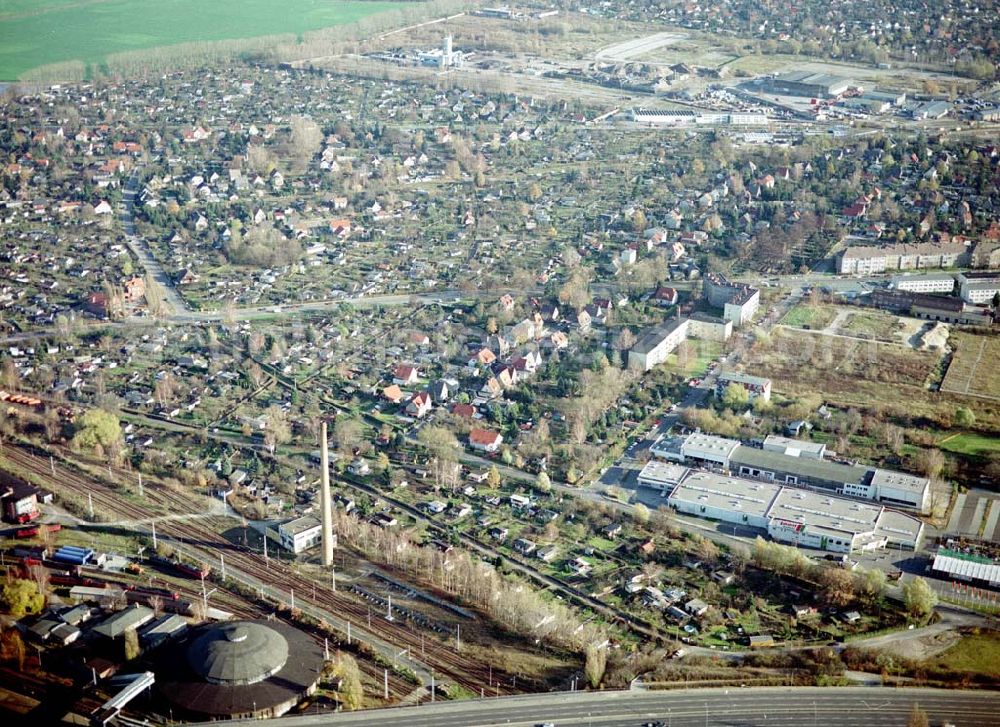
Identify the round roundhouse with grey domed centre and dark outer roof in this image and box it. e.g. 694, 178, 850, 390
156, 620, 323, 720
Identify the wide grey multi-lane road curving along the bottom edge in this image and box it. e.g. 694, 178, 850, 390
262, 687, 1000, 727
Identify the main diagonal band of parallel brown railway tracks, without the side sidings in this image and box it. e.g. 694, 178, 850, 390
3, 444, 530, 696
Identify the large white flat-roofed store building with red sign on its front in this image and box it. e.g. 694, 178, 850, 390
667, 471, 924, 553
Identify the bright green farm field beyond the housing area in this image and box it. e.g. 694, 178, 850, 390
0, 0, 404, 80
